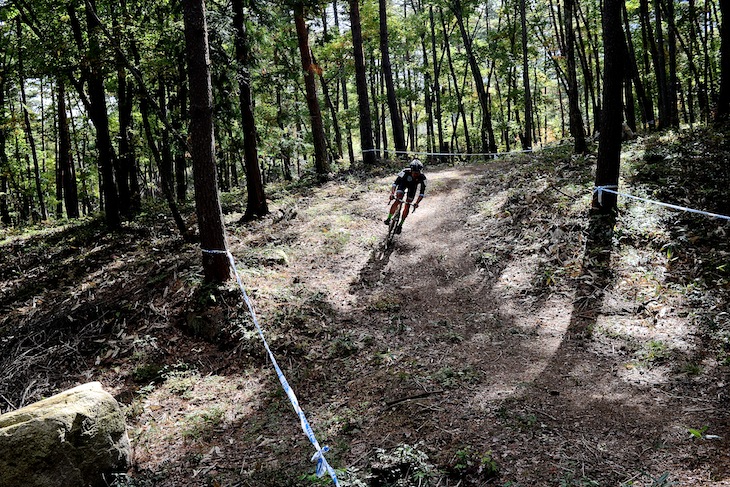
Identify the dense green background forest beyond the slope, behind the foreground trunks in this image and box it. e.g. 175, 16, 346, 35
0, 0, 727, 229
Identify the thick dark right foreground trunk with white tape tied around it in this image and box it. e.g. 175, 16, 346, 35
593, 0, 624, 212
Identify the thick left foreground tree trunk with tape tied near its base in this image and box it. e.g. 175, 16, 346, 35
182, 0, 230, 283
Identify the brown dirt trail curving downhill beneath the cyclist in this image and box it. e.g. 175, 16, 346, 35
278, 166, 730, 485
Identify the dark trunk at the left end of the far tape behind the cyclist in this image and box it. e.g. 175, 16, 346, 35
350, 0, 375, 165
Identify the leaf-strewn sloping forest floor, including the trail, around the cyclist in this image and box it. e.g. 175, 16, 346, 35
0, 131, 730, 487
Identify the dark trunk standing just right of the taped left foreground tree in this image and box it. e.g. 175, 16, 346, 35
233, 0, 269, 220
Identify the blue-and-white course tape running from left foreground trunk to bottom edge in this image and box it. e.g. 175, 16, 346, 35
203, 249, 340, 487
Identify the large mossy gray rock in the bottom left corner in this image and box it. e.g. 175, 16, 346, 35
0, 382, 132, 487
